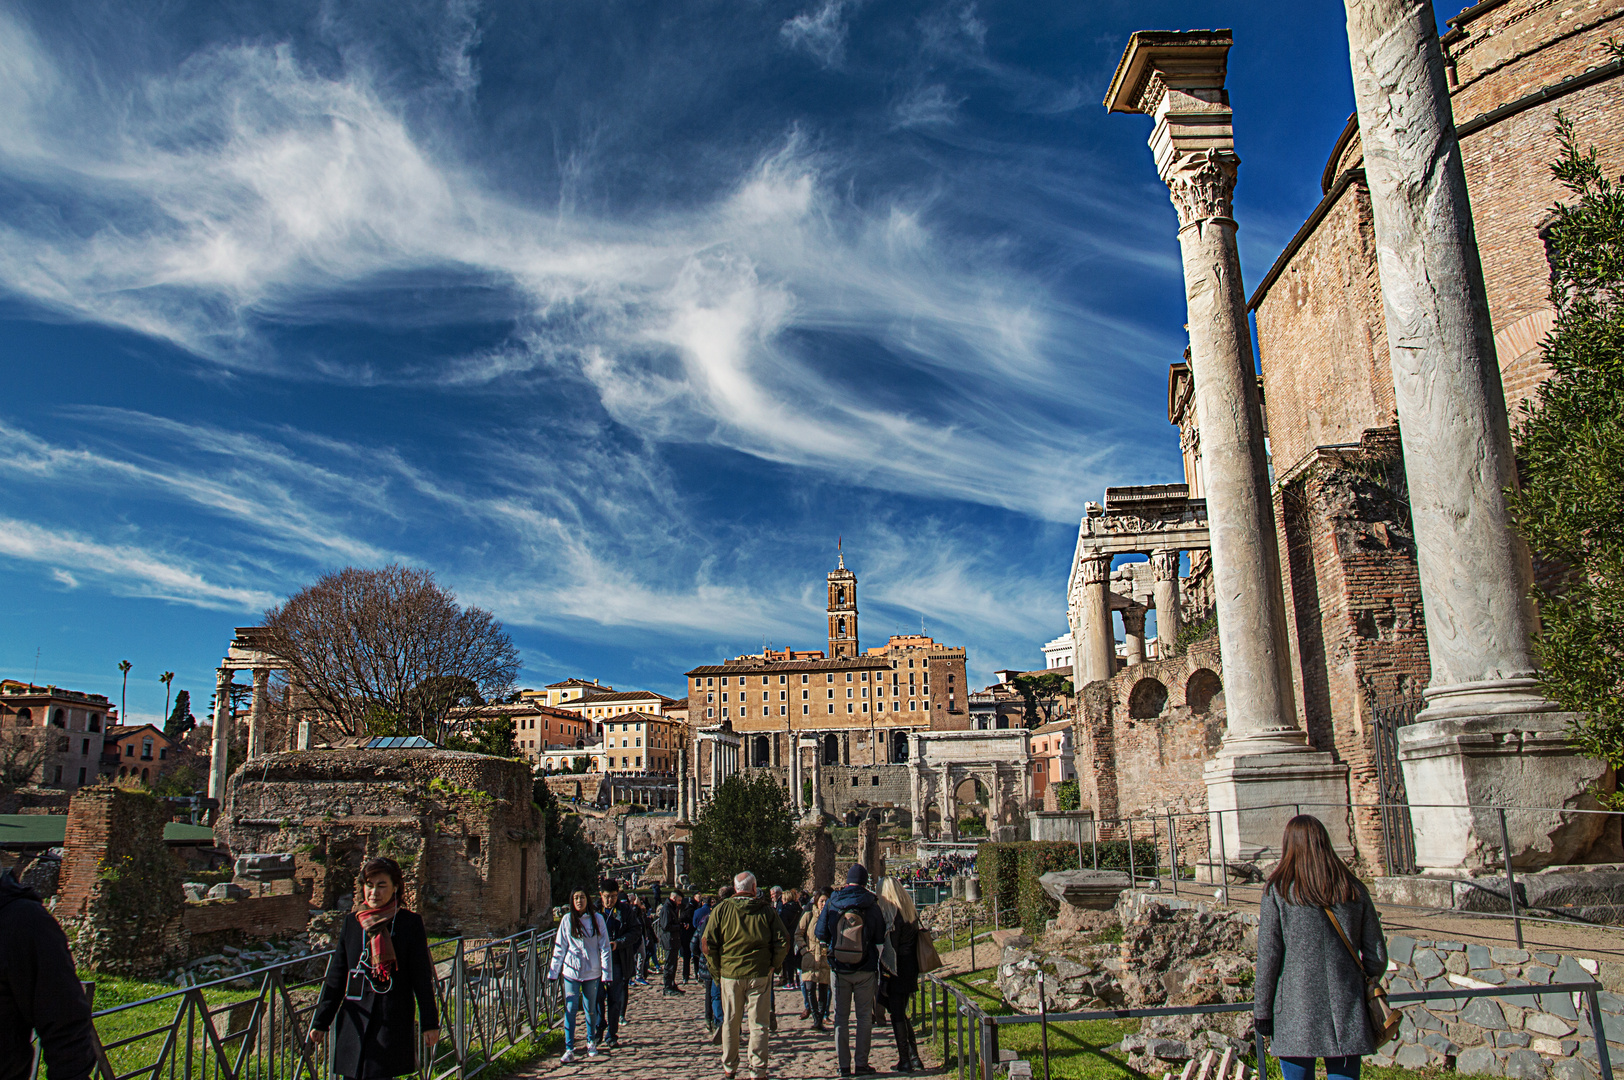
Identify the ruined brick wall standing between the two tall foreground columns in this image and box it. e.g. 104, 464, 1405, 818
1275, 427, 1429, 872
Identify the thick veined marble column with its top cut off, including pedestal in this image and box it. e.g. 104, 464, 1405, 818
1345, 0, 1605, 869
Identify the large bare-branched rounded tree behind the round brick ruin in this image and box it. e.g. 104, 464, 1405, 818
265, 564, 520, 737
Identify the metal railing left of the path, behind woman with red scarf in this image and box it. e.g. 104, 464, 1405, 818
29, 931, 564, 1080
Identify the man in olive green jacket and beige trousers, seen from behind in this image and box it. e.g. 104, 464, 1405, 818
700, 870, 789, 1080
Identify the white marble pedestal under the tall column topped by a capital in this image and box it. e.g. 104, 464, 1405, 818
1203, 747, 1353, 862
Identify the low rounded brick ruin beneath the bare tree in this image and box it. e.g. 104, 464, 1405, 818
214, 749, 551, 934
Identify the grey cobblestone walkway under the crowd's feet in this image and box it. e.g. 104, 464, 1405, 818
515, 983, 926, 1080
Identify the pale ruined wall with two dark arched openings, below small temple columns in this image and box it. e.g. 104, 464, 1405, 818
1072, 640, 1224, 858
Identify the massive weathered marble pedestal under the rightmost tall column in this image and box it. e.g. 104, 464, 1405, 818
1398, 706, 1614, 874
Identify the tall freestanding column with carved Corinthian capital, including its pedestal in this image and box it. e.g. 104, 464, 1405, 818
1106, 31, 1351, 856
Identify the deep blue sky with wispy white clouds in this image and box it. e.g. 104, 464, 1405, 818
0, 0, 1422, 718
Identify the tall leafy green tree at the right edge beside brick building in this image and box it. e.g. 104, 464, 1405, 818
1512, 111, 1624, 792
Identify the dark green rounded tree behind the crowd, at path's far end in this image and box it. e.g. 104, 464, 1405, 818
689, 771, 806, 888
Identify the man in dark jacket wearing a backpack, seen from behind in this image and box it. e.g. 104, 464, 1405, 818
814, 862, 885, 1077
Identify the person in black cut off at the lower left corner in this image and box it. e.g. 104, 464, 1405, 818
0, 870, 96, 1080
